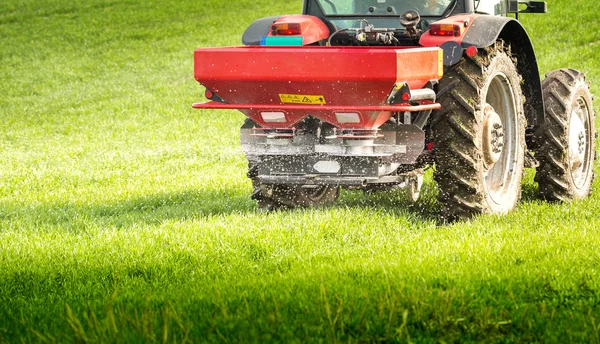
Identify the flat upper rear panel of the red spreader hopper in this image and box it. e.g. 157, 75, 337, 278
194, 47, 404, 83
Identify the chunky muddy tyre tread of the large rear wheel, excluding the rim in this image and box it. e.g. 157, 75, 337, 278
431, 43, 525, 221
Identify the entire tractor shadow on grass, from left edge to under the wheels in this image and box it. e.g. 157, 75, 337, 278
0, 172, 548, 232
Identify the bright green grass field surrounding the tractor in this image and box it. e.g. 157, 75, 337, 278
0, 0, 600, 343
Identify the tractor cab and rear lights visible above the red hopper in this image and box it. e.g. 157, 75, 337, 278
242, 0, 546, 47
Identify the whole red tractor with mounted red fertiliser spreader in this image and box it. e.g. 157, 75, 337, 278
193, 0, 596, 219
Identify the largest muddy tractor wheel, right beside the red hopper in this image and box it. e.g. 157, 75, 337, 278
431, 42, 526, 220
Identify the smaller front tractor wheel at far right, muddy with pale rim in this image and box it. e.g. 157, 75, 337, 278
535, 69, 596, 201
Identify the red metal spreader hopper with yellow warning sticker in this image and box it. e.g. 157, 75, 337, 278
194, 47, 441, 128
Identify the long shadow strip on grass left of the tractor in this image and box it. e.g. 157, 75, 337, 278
0, 189, 257, 232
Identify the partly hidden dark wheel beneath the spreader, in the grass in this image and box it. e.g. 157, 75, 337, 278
254, 185, 340, 210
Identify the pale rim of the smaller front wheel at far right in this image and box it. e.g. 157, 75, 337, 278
568, 96, 593, 189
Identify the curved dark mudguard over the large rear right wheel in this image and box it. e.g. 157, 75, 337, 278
461, 15, 544, 134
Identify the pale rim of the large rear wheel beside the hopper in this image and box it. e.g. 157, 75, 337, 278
482, 73, 521, 205
